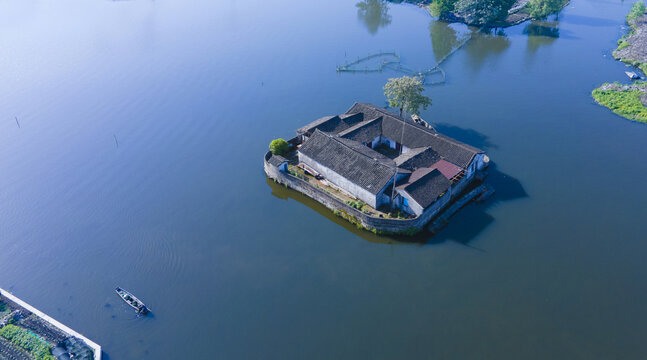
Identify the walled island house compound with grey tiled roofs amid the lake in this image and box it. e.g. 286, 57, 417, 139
264, 103, 490, 235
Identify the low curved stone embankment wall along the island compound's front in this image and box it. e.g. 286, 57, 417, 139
263, 152, 480, 235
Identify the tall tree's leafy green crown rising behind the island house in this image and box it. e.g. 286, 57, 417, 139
384, 76, 431, 116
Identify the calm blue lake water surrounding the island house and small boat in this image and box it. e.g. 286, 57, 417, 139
0, 0, 647, 359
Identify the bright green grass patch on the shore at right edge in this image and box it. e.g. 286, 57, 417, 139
592, 82, 647, 123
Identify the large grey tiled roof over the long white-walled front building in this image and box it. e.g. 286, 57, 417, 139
299, 130, 395, 194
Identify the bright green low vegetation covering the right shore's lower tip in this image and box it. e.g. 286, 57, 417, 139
592, 82, 647, 123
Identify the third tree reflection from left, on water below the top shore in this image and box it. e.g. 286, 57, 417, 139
465, 29, 510, 71
